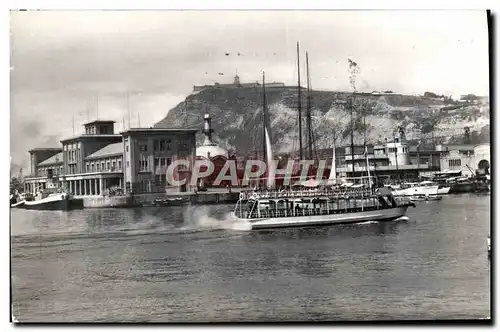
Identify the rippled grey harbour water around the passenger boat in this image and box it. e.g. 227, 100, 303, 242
11, 194, 491, 322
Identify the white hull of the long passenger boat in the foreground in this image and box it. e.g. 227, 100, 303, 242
237, 206, 408, 229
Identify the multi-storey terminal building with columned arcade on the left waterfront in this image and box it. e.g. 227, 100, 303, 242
24, 120, 197, 196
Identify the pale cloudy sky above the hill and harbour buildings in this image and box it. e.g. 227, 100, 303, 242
10, 10, 489, 171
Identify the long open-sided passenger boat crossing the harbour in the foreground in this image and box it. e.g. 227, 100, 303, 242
233, 188, 415, 229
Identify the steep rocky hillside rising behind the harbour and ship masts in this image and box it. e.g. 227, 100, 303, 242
155, 87, 490, 153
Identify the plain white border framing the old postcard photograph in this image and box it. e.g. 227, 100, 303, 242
0, 0, 500, 331
